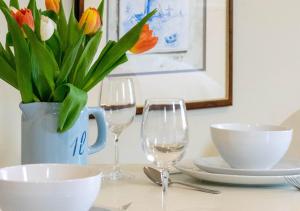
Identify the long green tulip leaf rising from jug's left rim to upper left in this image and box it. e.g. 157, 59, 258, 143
0, 7, 33, 103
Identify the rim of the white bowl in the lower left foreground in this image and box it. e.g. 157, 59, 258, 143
0, 163, 103, 184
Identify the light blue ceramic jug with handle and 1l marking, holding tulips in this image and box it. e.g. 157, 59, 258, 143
20, 103, 107, 164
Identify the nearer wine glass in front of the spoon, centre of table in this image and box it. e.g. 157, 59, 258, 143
141, 99, 188, 209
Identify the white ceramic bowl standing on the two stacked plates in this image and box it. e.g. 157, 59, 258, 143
210, 123, 293, 169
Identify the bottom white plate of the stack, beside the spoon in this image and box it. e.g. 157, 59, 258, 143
176, 164, 299, 186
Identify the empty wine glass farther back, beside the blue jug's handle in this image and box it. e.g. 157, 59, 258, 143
100, 77, 136, 180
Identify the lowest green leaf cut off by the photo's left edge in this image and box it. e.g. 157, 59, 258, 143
0, 56, 18, 89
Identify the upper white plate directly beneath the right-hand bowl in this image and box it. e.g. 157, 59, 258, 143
194, 157, 300, 176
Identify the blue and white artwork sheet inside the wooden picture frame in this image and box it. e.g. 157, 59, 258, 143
119, 0, 189, 53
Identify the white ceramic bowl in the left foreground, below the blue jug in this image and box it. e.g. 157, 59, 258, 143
0, 164, 102, 211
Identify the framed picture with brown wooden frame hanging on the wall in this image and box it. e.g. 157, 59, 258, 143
76, 0, 233, 113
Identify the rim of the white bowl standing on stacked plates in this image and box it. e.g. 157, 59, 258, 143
210, 123, 293, 133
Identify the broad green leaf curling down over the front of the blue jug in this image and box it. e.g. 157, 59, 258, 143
54, 84, 87, 133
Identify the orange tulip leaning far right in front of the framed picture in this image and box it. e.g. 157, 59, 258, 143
130, 24, 158, 54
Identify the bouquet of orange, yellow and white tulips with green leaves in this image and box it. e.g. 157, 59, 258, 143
0, 0, 157, 132
